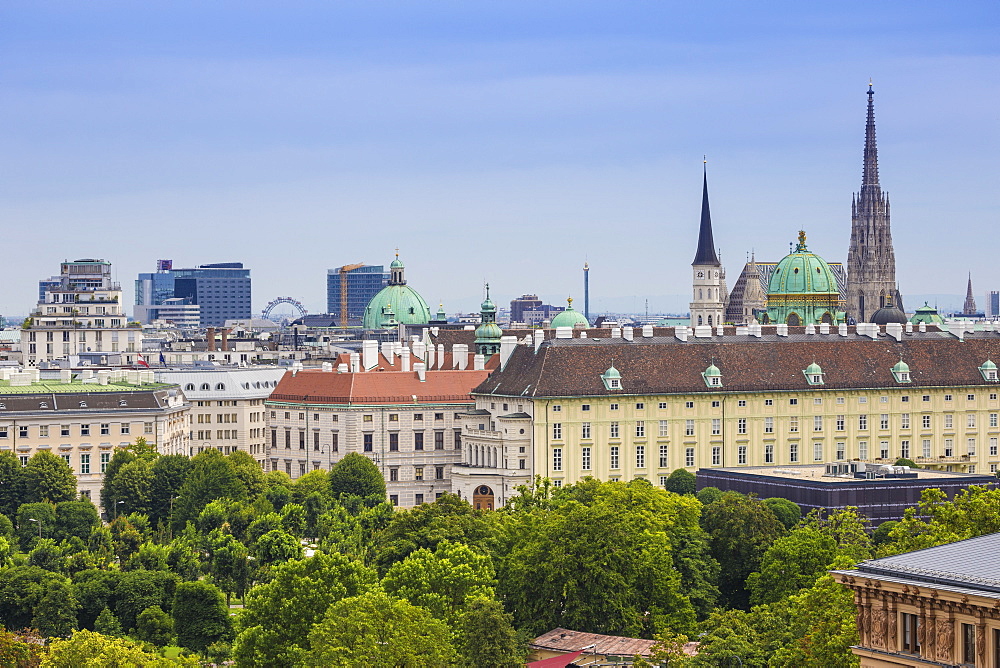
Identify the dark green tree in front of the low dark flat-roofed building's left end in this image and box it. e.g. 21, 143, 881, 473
702, 492, 784, 609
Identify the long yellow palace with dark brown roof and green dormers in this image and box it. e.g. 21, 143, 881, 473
456, 325, 1000, 506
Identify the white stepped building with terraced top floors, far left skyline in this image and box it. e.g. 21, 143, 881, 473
21, 259, 142, 366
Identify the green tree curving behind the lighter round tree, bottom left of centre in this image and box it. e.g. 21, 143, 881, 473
233, 552, 378, 666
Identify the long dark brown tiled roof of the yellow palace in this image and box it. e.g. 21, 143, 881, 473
475, 332, 1000, 397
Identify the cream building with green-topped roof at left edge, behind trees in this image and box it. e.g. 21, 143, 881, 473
0, 368, 190, 503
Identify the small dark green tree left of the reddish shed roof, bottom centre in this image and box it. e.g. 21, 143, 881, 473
455, 598, 525, 668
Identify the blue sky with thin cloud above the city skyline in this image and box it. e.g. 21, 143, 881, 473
0, 0, 1000, 314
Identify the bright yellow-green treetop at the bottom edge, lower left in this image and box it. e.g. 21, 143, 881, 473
42, 630, 199, 668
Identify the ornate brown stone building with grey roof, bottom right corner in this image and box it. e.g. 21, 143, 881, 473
834, 534, 1000, 668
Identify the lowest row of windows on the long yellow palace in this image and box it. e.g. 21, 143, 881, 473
552, 438, 1000, 473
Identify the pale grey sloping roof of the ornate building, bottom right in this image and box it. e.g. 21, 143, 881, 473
855, 533, 1000, 592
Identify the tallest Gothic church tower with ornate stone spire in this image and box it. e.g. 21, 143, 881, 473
847, 83, 903, 322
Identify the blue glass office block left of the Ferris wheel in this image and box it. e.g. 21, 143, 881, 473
135, 260, 252, 328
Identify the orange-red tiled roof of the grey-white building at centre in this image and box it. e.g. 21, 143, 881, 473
268, 369, 490, 404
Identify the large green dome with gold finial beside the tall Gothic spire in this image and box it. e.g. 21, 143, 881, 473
767, 231, 846, 326
